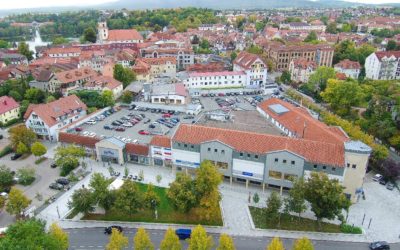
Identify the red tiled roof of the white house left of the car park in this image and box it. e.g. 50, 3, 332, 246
24, 95, 87, 127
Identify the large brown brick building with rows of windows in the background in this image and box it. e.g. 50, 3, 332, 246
265, 43, 334, 71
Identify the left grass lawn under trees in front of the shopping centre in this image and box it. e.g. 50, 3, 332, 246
82, 183, 222, 226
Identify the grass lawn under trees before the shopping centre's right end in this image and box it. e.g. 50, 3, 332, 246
249, 207, 342, 233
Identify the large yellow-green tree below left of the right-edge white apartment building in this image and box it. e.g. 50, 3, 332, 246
321, 79, 364, 116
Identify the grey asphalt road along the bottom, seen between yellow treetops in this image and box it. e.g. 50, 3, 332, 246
66, 228, 390, 250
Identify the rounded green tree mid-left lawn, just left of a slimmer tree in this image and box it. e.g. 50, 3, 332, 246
114, 180, 143, 215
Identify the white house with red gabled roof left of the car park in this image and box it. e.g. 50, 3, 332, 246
24, 95, 87, 141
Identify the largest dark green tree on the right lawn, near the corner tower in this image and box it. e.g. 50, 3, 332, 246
304, 172, 350, 228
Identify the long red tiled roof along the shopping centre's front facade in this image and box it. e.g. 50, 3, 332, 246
172, 124, 345, 167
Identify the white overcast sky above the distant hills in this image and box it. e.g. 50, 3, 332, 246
0, 0, 400, 10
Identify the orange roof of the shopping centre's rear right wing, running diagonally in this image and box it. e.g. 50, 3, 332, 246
258, 98, 349, 145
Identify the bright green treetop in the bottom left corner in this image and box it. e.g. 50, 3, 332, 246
0, 219, 59, 250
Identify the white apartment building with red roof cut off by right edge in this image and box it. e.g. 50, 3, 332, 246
365, 51, 400, 80
